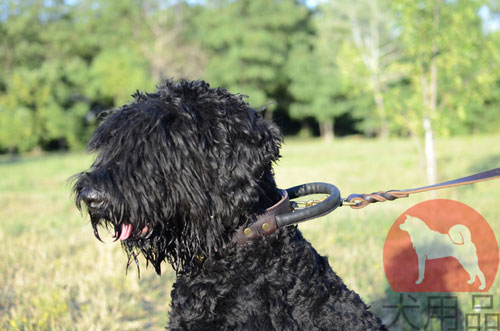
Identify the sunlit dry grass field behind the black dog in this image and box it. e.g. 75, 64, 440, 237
0, 136, 500, 330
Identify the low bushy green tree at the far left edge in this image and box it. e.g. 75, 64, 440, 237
0, 60, 88, 152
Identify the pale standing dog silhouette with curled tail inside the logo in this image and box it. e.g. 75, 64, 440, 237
399, 215, 486, 290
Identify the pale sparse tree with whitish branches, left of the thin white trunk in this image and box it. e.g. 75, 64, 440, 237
320, 0, 399, 137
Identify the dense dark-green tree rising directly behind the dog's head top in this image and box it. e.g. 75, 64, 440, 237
197, 0, 310, 118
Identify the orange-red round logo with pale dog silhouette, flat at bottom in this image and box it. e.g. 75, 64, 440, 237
384, 199, 499, 292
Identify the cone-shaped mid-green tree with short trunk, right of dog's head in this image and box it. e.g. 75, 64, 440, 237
287, 7, 361, 141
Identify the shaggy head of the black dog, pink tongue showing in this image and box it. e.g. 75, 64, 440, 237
73, 81, 281, 273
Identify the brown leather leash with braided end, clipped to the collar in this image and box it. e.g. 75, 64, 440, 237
342, 168, 500, 209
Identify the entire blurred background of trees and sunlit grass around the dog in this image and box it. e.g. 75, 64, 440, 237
0, 0, 500, 330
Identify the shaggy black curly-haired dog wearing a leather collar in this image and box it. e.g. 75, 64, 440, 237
74, 81, 385, 330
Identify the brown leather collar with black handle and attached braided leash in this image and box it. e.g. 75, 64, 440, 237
234, 168, 500, 246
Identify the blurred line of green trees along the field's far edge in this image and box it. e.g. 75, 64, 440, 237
0, 0, 500, 153
